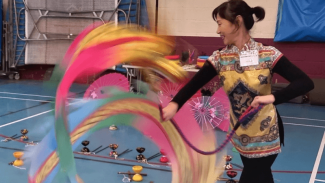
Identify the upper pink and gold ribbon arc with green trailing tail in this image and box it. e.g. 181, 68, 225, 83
51, 24, 186, 180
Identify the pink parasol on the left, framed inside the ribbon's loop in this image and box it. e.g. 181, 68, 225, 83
84, 73, 130, 99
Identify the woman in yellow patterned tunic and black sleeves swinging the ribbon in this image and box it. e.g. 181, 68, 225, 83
163, 0, 314, 183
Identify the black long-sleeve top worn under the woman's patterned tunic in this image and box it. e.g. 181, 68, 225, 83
172, 56, 314, 144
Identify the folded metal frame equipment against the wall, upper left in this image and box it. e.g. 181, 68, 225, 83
0, 0, 141, 79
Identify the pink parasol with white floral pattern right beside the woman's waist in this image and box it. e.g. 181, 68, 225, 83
189, 89, 229, 131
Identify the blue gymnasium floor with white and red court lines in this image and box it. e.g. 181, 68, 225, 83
0, 79, 325, 183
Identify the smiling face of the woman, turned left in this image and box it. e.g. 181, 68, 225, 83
217, 14, 237, 45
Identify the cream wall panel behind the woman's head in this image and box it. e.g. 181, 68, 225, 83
151, 0, 278, 38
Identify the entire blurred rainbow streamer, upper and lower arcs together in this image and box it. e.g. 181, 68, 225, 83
29, 24, 215, 183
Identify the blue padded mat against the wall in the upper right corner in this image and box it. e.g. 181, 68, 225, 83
274, 0, 325, 42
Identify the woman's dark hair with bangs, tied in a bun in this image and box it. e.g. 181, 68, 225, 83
212, 0, 265, 30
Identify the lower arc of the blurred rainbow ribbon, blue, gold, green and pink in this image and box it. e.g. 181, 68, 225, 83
29, 92, 216, 183
